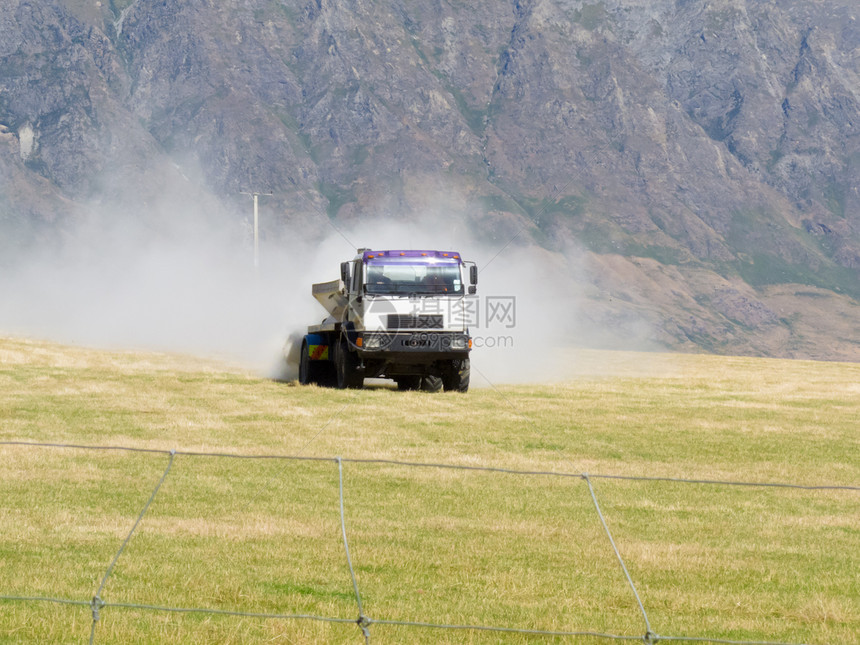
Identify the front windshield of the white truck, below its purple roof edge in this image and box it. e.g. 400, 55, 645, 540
365, 263, 463, 294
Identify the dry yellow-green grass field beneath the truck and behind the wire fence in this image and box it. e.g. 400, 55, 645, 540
0, 338, 860, 644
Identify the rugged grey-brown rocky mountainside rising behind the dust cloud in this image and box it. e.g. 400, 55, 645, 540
0, 0, 860, 360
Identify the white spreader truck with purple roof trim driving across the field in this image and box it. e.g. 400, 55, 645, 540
299, 248, 478, 392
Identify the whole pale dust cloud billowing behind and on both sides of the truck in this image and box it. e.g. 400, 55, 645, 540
0, 182, 656, 387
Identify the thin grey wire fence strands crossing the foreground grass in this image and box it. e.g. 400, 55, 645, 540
0, 441, 860, 645
